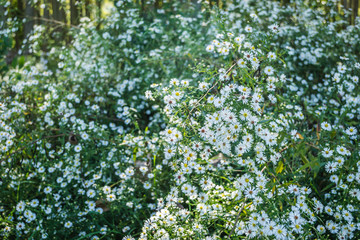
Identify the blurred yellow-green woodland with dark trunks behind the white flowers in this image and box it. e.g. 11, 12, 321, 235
0, 0, 360, 69
